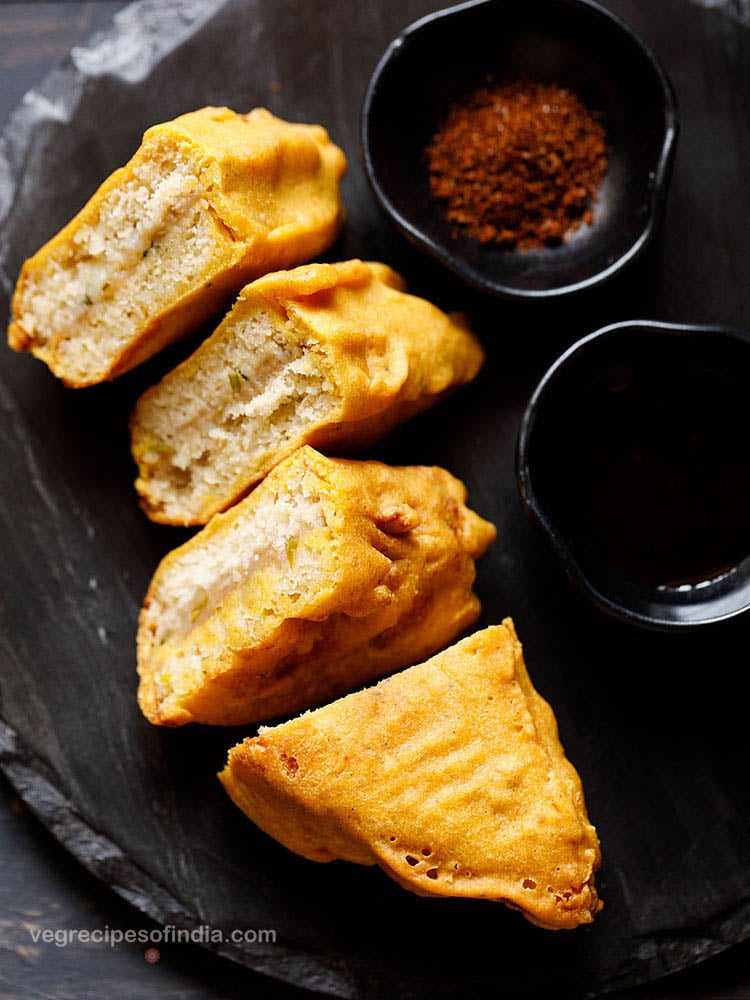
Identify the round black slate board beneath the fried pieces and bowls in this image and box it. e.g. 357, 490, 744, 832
0, 0, 750, 997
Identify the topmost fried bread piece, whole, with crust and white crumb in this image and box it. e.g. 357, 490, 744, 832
8, 108, 346, 387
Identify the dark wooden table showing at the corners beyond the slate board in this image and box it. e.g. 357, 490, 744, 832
0, 0, 750, 1000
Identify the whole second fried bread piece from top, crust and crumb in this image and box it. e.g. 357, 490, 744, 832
131, 260, 483, 525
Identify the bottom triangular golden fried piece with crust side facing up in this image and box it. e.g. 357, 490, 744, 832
219, 619, 602, 930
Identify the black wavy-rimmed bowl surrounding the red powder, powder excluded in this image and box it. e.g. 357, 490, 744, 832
362, 0, 677, 298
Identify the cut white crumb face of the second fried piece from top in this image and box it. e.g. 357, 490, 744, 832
133, 308, 338, 523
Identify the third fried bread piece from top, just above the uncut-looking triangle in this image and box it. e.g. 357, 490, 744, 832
137, 446, 495, 726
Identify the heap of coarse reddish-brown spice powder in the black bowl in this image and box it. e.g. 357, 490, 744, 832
425, 78, 607, 250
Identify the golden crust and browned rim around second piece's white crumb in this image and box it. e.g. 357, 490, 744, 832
131, 260, 484, 525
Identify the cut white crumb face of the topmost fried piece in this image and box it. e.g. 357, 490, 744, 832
16, 146, 221, 382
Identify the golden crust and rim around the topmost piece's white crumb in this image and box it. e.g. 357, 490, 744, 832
8, 107, 346, 388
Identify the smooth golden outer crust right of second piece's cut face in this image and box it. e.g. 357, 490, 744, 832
243, 260, 484, 438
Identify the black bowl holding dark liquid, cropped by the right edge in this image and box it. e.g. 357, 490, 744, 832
517, 321, 750, 629
